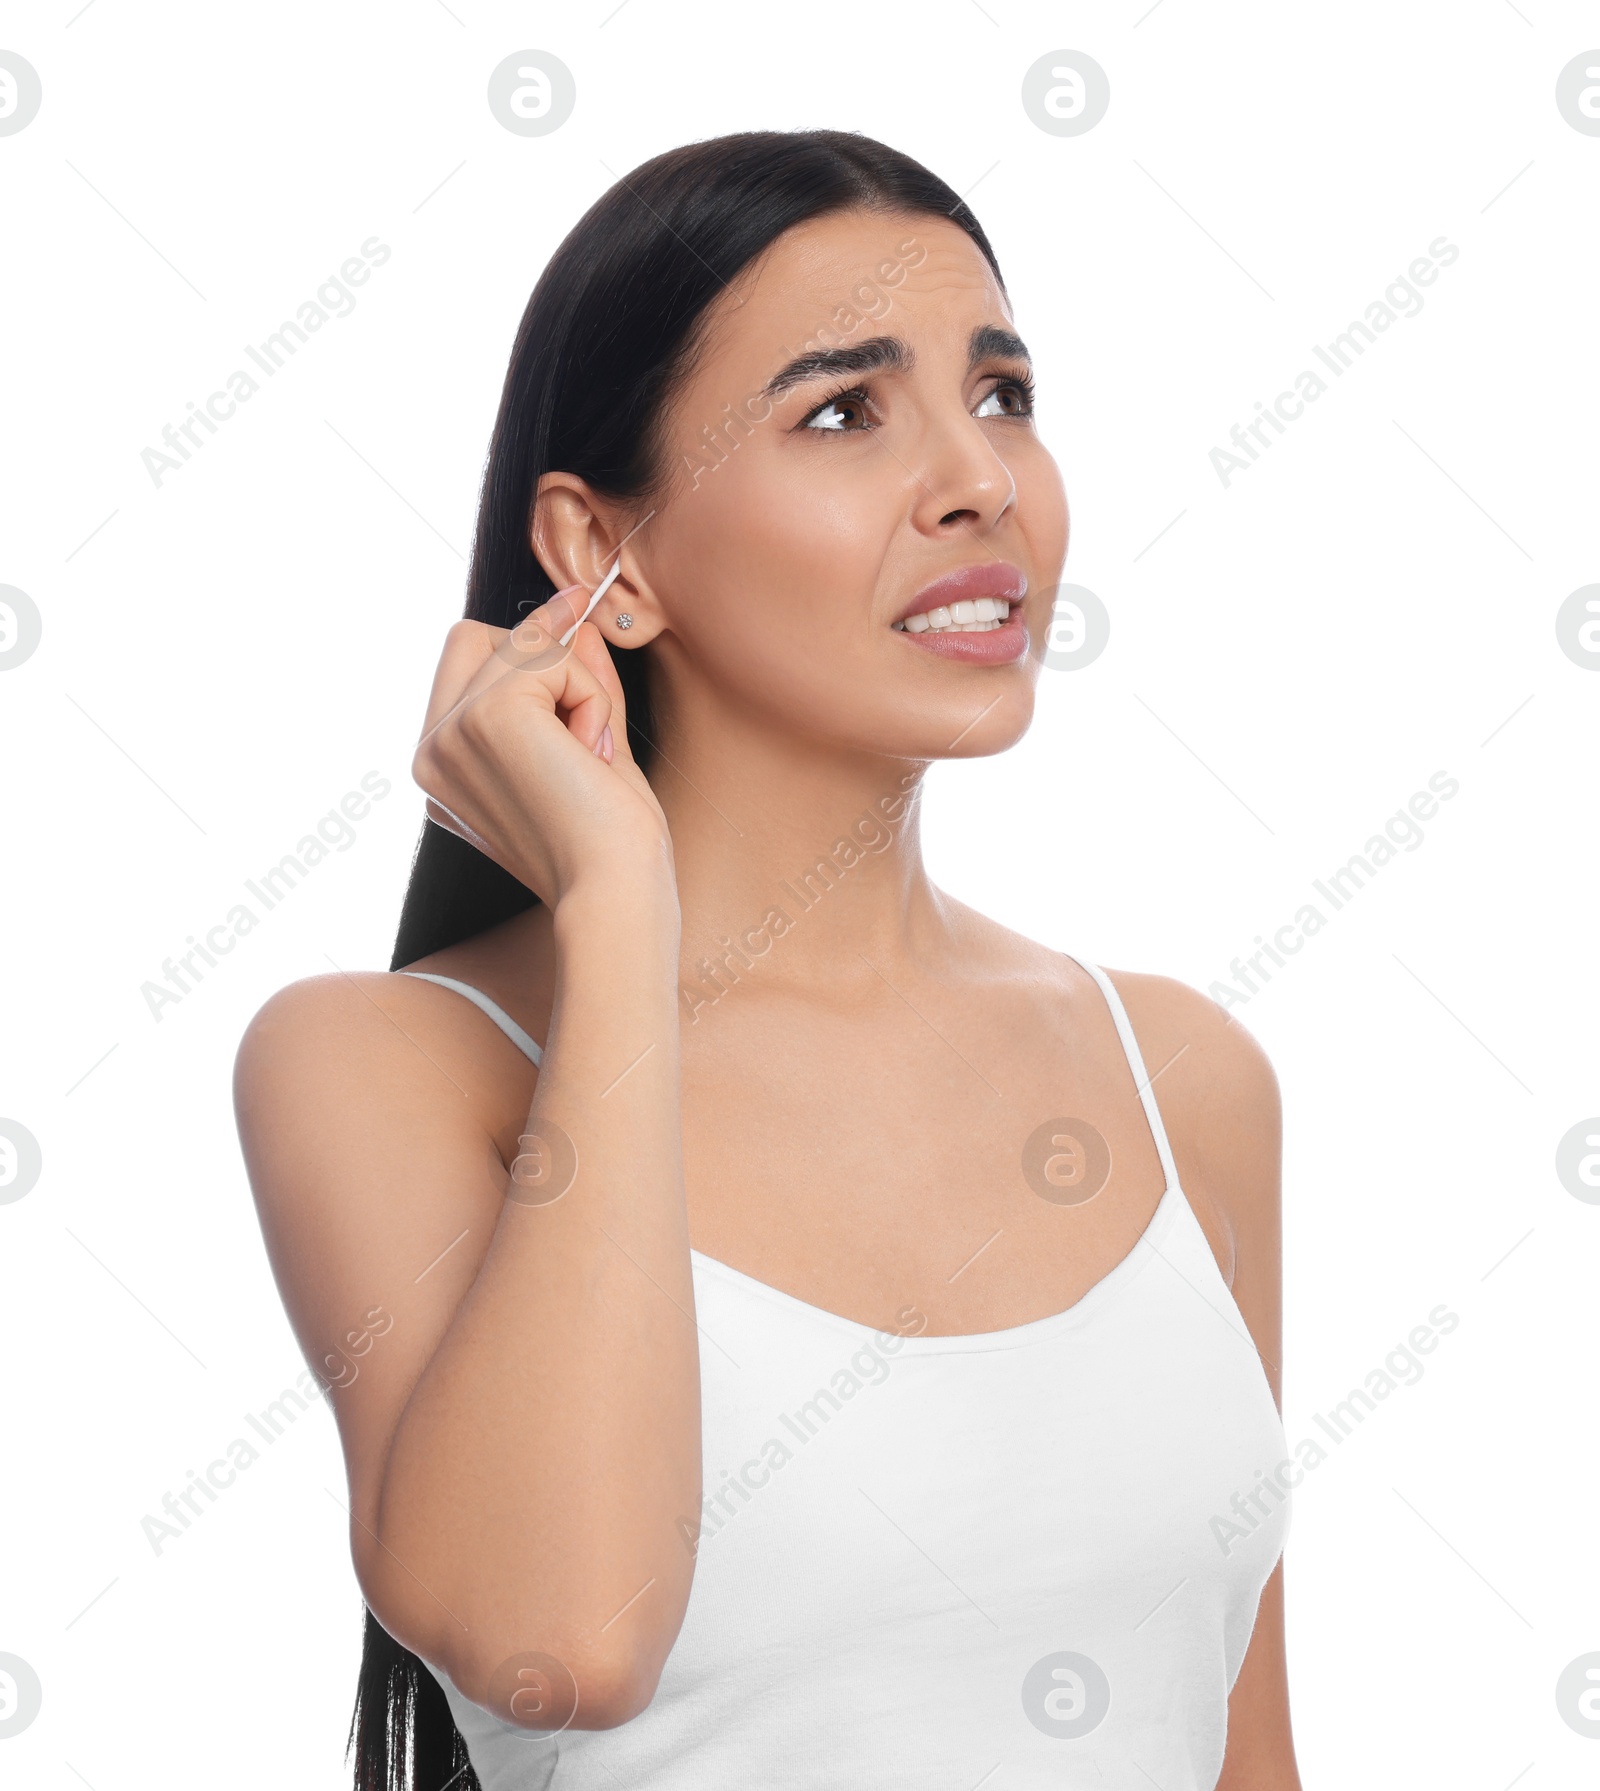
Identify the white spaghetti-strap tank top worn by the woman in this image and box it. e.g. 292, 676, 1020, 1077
407, 960, 1288, 1791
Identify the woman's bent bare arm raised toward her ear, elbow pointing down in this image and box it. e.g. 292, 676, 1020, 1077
237, 605, 701, 1727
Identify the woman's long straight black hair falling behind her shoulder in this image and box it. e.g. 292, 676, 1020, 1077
351, 131, 1000, 1791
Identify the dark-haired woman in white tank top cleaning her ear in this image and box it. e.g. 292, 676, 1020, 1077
237, 131, 1299, 1791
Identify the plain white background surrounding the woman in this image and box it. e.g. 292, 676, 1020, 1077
0, 0, 1600, 1791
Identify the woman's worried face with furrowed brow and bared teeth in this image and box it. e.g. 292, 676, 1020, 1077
607, 210, 1068, 759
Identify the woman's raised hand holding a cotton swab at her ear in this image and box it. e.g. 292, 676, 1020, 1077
412, 584, 672, 910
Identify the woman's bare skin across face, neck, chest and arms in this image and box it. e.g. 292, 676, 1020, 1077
237, 211, 1299, 1791
